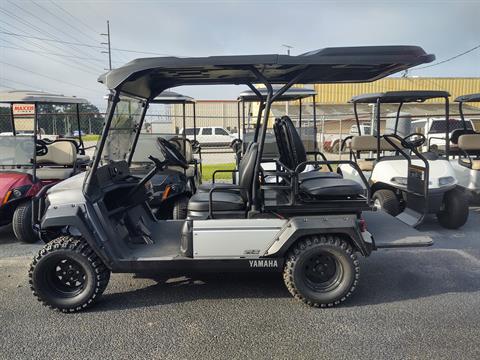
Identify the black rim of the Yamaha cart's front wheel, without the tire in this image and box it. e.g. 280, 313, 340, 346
46, 258, 87, 298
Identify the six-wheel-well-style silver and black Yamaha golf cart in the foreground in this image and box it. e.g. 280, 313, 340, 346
29, 46, 434, 312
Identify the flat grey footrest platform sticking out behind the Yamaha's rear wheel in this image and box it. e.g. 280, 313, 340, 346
362, 211, 433, 249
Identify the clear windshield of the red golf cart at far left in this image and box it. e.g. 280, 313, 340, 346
0, 135, 35, 167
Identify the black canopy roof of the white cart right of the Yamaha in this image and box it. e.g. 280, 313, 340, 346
350, 90, 450, 104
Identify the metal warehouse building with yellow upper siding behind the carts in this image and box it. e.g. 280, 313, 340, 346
168, 77, 480, 133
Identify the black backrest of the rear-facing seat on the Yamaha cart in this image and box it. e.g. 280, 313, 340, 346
280, 116, 307, 172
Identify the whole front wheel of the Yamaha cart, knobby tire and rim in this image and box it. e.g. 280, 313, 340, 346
28, 236, 110, 313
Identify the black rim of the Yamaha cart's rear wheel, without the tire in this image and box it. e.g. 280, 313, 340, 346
303, 251, 343, 292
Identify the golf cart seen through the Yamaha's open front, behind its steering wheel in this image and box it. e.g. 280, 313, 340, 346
129, 91, 202, 219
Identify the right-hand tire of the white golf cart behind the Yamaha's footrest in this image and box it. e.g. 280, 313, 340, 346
437, 188, 469, 229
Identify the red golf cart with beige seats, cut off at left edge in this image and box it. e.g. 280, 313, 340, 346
0, 91, 89, 243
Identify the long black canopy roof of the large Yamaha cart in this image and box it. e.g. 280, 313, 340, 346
98, 46, 435, 99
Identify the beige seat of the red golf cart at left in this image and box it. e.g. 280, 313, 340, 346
36, 140, 77, 180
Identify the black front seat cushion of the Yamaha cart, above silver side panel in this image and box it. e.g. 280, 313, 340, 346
188, 191, 245, 211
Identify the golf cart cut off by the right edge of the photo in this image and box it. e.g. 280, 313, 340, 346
450, 93, 480, 195
